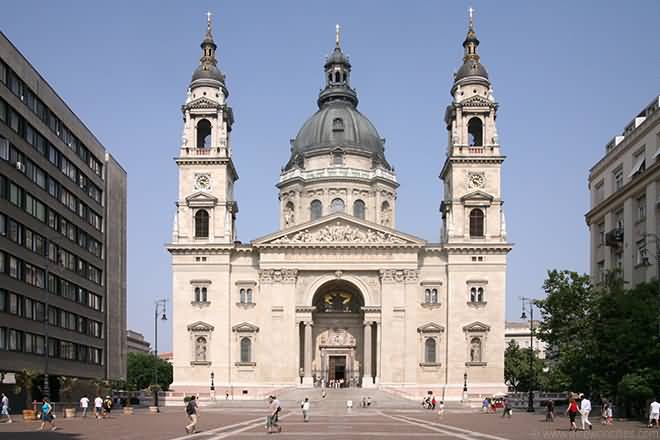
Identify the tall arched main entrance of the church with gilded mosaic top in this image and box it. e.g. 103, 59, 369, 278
302, 280, 364, 387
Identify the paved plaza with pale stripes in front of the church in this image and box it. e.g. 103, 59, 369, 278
0, 402, 660, 440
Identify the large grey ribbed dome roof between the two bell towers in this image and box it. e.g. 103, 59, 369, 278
292, 100, 384, 157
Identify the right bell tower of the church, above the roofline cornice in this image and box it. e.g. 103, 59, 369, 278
440, 8, 506, 244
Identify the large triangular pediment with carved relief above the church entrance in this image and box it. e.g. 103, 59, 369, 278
252, 213, 425, 246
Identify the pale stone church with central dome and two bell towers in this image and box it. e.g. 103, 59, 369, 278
167, 14, 512, 400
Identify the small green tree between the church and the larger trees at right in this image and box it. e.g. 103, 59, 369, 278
504, 341, 544, 392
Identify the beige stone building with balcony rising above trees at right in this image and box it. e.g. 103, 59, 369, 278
586, 96, 660, 285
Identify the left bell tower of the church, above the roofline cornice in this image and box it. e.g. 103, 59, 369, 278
172, 13, 238, 244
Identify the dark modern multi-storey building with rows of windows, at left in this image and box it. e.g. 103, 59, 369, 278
0, 33, 126, 379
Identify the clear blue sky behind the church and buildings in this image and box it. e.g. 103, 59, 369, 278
0, 0, 660, 351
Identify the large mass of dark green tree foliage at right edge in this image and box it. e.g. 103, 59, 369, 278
537, 271, 660, 410
